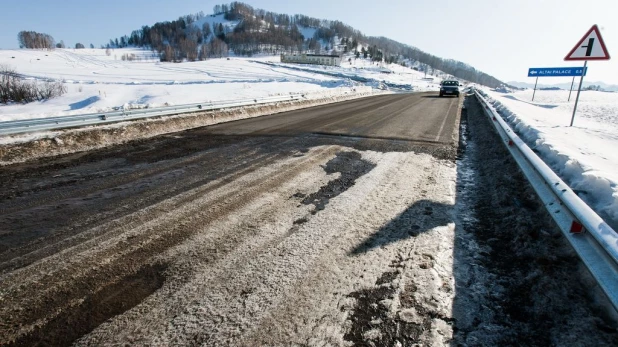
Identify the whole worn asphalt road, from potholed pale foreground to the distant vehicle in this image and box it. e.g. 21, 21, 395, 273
0, 93, 461, 346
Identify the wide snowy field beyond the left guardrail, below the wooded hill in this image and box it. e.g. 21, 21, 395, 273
0, 48, 439, 121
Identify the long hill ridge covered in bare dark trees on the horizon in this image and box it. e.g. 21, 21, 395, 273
107, 2, 504, 88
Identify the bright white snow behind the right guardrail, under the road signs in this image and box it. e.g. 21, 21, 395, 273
484, 90, 618, 228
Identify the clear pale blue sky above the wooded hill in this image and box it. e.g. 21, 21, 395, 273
0, 0, 618, 84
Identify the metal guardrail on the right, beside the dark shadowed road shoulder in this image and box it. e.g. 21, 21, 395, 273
475, 91, 618, 310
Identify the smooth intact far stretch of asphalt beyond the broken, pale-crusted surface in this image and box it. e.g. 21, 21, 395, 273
206, 93, 461, 144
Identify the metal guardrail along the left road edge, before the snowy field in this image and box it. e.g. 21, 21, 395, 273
0, 94, 304, 136
